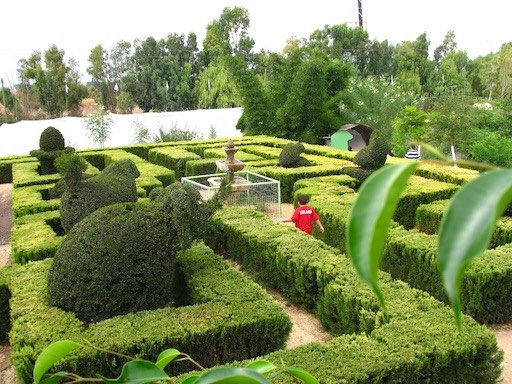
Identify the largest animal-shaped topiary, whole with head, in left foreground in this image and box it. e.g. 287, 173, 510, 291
48, 182, 220, 322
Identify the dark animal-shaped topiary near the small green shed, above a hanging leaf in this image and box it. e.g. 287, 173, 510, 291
342, 130, 390, 183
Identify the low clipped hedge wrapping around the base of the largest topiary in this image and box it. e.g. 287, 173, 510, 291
0, 244, 291, 384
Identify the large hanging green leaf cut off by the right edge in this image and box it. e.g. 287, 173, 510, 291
438, 169, 512, 328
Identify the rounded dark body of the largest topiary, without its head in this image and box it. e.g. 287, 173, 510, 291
48, 203, 174, 322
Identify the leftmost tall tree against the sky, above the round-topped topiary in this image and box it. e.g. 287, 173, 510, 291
18, 45, 69, 117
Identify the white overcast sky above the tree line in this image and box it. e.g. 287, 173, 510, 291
0, 0, 512, 87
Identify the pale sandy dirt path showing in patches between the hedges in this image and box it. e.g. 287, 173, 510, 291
0, 190, 512, 384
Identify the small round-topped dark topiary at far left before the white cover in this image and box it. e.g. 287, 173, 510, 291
30, 126, 75, 175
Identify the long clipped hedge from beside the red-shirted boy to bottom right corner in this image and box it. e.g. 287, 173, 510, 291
202, 208, 503, 384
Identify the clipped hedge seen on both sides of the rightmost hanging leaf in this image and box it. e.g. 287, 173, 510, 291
381, 227, 512, 324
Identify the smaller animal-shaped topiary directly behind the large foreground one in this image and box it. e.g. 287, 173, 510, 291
60, 159, 140, 233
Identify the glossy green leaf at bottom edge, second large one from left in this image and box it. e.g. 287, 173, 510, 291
98, 359, 169, 384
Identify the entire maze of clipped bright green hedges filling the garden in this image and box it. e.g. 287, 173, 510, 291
0, 136, 504, 383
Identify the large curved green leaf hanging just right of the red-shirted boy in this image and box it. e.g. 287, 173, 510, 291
347, 161, 418, 310
